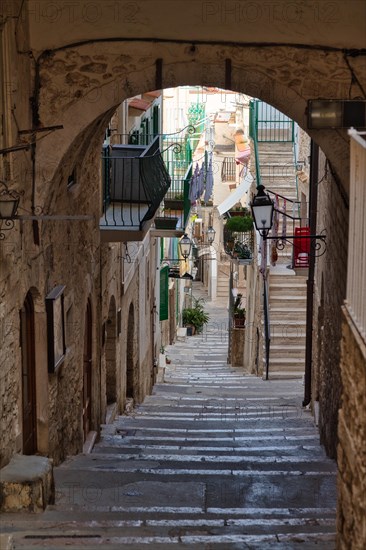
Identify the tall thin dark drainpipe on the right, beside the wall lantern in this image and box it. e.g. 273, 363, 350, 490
302, 140, 319, 407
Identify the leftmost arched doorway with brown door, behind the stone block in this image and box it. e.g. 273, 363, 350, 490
20, 292, 37, 455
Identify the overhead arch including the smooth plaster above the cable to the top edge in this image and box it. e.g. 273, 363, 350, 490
22, 0, 366, 197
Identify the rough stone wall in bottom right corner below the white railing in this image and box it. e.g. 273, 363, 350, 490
337, 307, 366, 550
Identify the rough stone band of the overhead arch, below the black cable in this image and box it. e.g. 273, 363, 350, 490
34, 40, 366, 203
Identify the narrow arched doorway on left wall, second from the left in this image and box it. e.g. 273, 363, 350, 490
83, 300, 93, 441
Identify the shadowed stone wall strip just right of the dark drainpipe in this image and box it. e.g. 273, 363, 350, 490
312, 151, 348, 458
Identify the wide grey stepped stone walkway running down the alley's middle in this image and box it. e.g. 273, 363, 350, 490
2, 288, 336, 550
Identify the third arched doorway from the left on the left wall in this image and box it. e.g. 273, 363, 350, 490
105, 296, 117, 405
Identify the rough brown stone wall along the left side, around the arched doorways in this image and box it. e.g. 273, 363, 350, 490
0, 15, 160, 467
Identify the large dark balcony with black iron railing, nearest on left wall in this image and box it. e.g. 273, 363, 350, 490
99, 138, 171, 242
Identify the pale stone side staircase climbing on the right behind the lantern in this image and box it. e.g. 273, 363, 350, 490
259, 142, 307, 378
